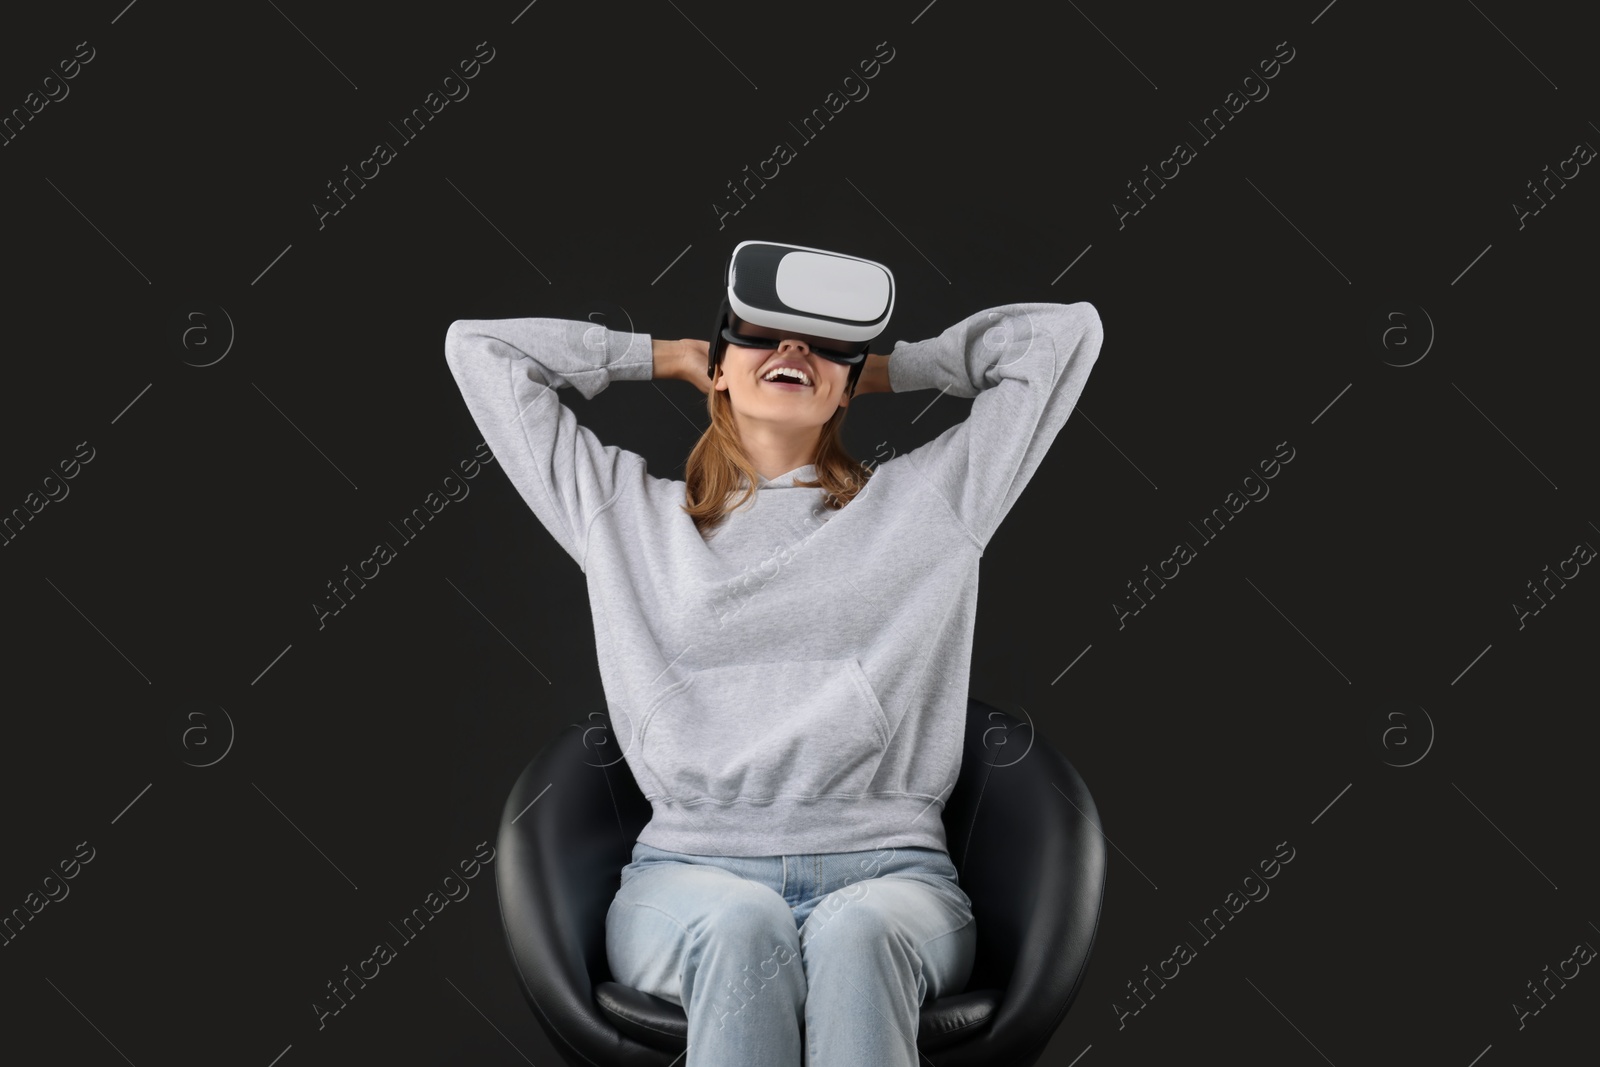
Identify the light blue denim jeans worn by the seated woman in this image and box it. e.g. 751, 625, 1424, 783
606, 841, 978, 1067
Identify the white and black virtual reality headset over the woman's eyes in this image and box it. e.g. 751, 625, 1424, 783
706, 242, 894, 390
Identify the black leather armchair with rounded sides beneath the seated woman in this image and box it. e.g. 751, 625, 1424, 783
494, 699, 1106, 1067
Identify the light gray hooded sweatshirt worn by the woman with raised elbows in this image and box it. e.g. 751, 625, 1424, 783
445, 302, 1102, 856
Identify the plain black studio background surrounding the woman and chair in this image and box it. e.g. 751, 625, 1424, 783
0, 0, 1600, 1067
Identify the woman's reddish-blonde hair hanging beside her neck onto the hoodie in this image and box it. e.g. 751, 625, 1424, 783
683, 368, 872, 536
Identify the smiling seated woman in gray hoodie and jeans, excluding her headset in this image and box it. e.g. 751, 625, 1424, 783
445, 279, 1102, 1067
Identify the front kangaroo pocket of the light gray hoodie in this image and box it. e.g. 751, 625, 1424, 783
638, 656, 888, 803
